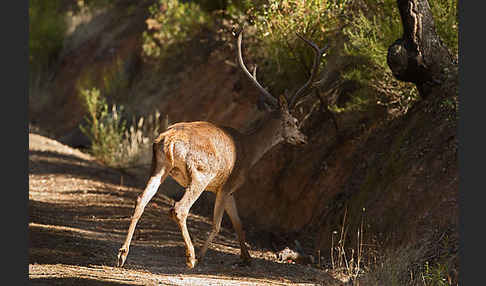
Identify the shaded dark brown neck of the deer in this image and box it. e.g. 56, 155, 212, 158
243, 119, 283, 167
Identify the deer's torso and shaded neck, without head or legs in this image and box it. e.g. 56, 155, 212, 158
152, 119, 290, 194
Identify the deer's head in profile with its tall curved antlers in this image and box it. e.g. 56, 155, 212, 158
235, 28, 327, 145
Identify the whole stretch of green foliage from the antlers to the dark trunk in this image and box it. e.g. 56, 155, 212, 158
238, 0, 418, 112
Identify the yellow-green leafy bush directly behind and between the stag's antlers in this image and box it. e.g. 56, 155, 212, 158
246, 0, 349, 93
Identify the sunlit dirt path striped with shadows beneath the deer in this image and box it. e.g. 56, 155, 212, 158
29, 134, 339, 285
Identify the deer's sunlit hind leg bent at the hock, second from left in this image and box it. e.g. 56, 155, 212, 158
171, 173, 212, 268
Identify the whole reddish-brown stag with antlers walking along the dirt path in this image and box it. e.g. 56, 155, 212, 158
118, 26, 324, 268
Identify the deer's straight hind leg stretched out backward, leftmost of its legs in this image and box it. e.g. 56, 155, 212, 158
117, 165, 170, 267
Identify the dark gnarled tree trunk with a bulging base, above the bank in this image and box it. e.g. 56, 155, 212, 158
387, 0, 457, 98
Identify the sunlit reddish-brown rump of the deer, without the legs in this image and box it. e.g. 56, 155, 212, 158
152, 121, 237, 192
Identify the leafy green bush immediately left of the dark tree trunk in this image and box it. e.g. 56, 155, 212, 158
343, 0, 418, 113
